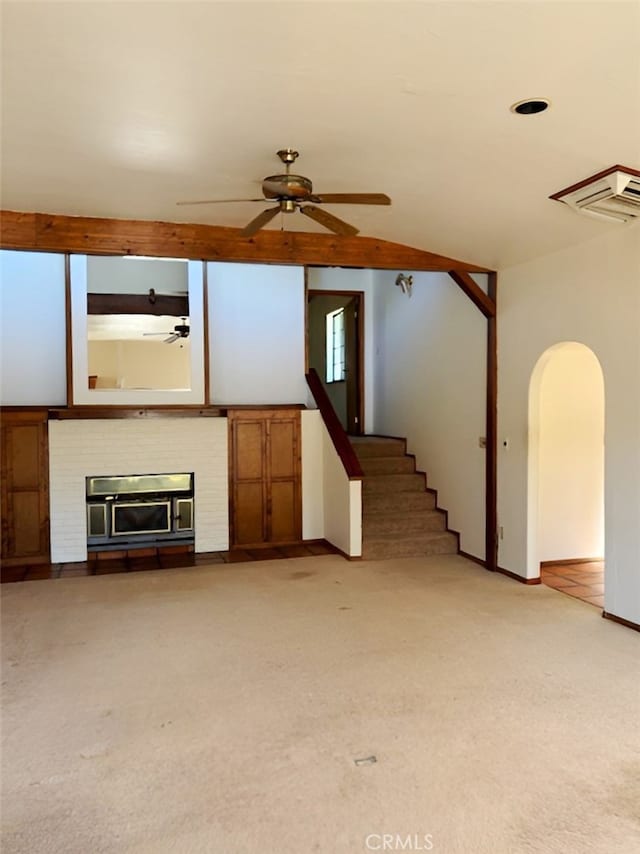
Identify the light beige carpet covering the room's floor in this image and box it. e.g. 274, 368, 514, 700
2, 556, 640, 854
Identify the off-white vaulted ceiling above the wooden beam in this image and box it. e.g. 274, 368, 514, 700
2, 0, 640, 267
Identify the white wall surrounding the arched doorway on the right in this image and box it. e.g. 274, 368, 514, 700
498, 224, 640, 622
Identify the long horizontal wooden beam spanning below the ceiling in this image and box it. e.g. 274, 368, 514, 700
0, 211, 490, 273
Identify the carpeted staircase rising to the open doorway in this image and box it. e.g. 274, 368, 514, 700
350, 436, 458, 560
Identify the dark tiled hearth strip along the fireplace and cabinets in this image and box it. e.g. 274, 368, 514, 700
1, 542, 337, 584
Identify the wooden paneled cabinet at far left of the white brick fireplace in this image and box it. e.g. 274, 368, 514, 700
0, 410, 49, 566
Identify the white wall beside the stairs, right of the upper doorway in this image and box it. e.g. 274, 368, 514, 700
374, 270, 487, 559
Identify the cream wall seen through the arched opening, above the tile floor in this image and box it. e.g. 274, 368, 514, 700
529, 342, 604, 561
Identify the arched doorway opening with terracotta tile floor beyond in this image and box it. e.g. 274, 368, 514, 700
528, 341, 605, 607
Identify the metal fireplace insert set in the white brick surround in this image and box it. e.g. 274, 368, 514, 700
87, 472, 194, 551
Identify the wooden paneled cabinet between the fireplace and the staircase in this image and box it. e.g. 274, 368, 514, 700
228, 409, 302, 546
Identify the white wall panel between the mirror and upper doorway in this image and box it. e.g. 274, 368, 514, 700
208, 263, 307, 404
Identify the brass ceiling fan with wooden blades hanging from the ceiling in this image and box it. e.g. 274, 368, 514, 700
177, 148, 391, 237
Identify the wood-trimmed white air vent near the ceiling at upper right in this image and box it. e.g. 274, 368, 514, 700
549, 166, 640, 222
